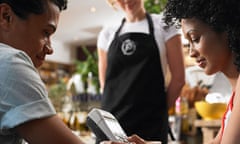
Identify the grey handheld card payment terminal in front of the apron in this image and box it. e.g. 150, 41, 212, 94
87, 108, 128, 143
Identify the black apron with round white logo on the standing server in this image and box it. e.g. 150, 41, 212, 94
102, 14, 168, 144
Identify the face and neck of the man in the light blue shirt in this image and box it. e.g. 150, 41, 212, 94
6, 2, 60, 67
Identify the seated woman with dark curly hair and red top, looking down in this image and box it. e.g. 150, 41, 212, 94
101, 0, 240, 144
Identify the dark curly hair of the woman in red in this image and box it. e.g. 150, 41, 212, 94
164, 0, 240, 71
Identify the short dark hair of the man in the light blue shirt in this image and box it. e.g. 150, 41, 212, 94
0, 0, 67, 19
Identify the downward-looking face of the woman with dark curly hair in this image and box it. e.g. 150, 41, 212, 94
182, 19, 232, 74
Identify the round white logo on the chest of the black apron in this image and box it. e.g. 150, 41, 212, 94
121, 39, 136, 55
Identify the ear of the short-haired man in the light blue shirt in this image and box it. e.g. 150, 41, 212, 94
0, 3, 13, 29
